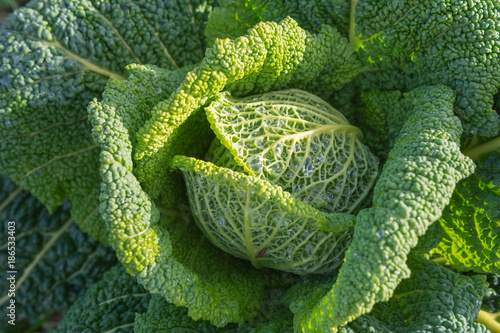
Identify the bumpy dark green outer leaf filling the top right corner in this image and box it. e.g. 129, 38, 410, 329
355, 0, 500, 137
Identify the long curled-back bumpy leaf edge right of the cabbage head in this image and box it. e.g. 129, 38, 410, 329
303, 86, 474, 332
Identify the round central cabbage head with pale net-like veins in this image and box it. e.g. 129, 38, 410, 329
173, 89, 378, 274
